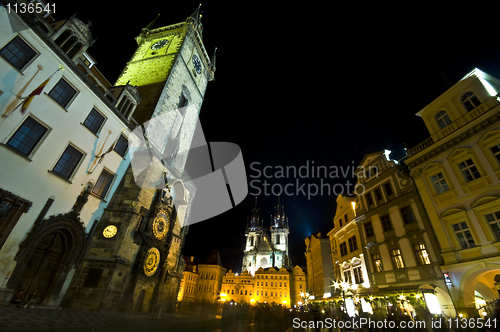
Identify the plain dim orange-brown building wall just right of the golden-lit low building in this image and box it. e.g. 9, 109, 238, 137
305, 232, 335, 298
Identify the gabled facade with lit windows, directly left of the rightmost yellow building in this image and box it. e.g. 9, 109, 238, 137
354, 151, 455, 317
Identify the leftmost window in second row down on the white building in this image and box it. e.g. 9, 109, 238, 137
7, 116, 48, 156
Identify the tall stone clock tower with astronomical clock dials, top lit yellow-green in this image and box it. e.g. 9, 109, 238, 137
62, 8, 215, 312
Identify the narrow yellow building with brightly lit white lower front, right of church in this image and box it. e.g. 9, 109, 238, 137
328, 195, 370, 293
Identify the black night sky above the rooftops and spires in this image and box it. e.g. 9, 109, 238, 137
52, 1, 500, 271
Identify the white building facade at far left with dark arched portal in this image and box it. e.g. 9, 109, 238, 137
0, 0, 141, 306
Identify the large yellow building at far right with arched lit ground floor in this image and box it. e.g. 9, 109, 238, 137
406, 69, 500, 317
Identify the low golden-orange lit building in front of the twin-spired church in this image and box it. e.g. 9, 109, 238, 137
221, 266, 306, 308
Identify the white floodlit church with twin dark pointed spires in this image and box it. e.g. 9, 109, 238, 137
242, 198, 291, 275
